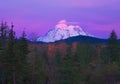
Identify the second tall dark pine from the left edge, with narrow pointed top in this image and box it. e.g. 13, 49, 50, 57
5, 25, 18, 84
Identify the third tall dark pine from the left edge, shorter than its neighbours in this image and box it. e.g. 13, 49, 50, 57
16, 31, 29, 83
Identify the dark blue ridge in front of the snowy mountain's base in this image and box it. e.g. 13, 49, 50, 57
37, 35, 109, 44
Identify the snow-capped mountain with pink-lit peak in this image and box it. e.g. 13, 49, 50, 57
37, 20, 93, 43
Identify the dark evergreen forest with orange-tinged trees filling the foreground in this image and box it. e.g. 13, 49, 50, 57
0, 22, 120, 84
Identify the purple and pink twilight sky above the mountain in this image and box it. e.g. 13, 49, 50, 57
0, 0, 120, 38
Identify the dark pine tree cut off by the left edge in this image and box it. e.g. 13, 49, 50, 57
0, 22, 8, 84
